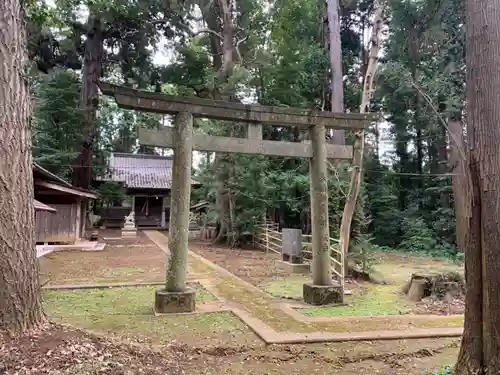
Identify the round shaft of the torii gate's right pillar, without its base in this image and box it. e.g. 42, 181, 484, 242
309, 125, 332, 286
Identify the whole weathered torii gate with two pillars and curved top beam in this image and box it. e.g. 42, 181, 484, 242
99, 82, 373, 313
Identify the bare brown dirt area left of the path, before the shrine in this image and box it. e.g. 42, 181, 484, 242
39, 231, 167, 285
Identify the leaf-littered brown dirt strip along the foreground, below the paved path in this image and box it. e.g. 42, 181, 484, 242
0, 324, 458, 375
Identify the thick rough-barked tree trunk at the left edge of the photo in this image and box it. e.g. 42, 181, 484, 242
0, 0, 44, 333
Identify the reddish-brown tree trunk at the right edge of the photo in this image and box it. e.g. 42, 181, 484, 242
455, 0, 500, 375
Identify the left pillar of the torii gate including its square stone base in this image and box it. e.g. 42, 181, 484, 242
155, 113, 195, 313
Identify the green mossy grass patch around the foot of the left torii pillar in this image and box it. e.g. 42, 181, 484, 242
44, 284, 256, 346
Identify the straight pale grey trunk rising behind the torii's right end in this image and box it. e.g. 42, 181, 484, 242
326, 0, 345, 145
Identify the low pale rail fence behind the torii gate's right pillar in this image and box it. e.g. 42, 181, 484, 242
254, 221, 345, 288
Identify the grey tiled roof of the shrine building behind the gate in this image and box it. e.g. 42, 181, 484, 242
106, 153, 172, 189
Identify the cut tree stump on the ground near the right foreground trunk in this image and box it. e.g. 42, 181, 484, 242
402, 272, 465, 302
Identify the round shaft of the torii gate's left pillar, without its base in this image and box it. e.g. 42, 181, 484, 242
165, 112, 193, 292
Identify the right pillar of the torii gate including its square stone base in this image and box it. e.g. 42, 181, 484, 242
303, 125, 343, 305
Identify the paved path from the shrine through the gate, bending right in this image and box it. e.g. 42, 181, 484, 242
144, 231, 463, 344
